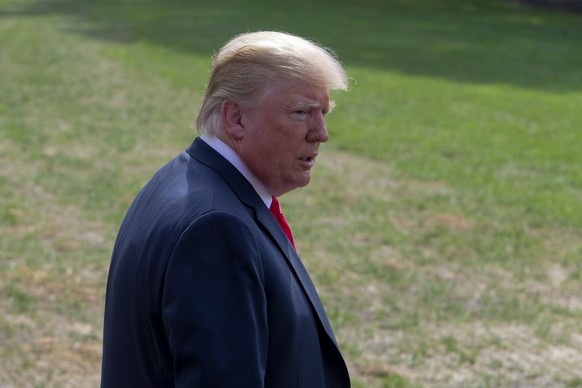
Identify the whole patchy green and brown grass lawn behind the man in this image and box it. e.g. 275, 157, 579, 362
0, 0, 582, 387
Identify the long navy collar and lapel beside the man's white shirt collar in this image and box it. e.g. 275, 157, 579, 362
187, 138, 339, 350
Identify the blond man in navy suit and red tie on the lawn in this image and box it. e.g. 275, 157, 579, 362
102, 32, 350, 388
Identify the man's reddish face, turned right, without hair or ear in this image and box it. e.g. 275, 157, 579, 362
239, 84, 330, 196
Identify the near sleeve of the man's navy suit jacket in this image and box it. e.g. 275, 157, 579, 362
162, 211, 268, 387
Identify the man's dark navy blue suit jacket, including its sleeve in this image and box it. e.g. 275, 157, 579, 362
101, 139, 350, 388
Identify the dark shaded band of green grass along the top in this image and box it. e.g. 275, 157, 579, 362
0, 0, 582, 92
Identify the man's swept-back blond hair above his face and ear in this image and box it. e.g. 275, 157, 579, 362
196, 31, 348, 136
